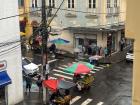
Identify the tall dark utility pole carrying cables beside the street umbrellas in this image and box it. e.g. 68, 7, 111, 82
41, 0, 48, 104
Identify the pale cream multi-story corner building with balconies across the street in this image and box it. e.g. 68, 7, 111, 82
27, 0, 125, 51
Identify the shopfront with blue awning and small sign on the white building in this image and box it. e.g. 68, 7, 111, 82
0, 61, 11, 105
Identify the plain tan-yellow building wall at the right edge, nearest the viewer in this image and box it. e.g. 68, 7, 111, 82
126, 0, 140, 105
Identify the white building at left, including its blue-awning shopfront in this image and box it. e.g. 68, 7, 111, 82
0, 0, 23, 105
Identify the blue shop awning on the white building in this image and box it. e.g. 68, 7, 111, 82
0, 71, 11, 87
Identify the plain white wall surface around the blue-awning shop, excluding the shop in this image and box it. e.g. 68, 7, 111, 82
0, 0, 23, 105
